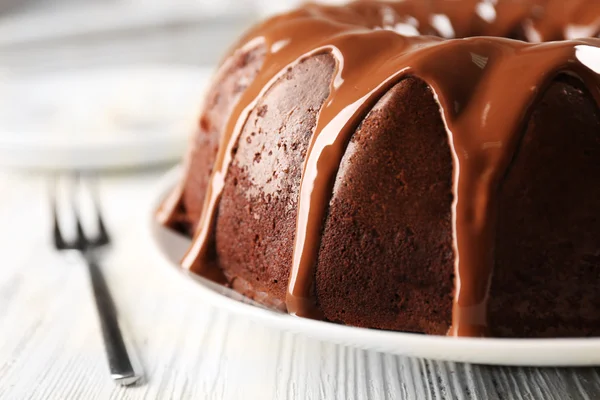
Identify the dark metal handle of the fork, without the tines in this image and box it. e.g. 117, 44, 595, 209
84, 255, 142, 386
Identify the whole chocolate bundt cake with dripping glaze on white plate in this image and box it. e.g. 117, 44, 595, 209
158, 0, 600, 337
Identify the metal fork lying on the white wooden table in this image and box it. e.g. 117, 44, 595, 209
50, 173, 142, 386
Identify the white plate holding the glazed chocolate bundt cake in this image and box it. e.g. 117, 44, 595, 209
146, 168, 600, 367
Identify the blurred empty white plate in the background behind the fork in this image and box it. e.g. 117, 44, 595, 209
0, 66, 211, 169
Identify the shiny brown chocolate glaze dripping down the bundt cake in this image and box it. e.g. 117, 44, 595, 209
162, 0, 600, 336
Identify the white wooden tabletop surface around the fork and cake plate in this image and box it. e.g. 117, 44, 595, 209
0, 170, 600, 400
